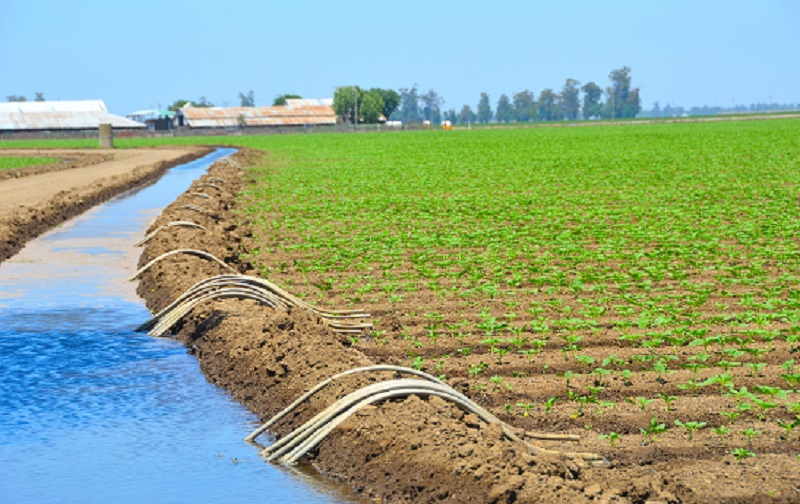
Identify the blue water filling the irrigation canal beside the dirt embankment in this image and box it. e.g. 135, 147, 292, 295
0, 149, 355, 504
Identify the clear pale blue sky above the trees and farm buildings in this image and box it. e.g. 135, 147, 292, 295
0, 0, 800, 114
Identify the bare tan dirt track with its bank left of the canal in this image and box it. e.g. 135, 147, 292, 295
0, 147, 210, 262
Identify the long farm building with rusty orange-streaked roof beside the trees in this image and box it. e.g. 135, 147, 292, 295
177, 99, 336, 128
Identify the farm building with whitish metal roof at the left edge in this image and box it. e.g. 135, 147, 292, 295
0, 100, 145, 132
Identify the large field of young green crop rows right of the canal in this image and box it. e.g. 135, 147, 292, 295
237, 120, 800, 476
